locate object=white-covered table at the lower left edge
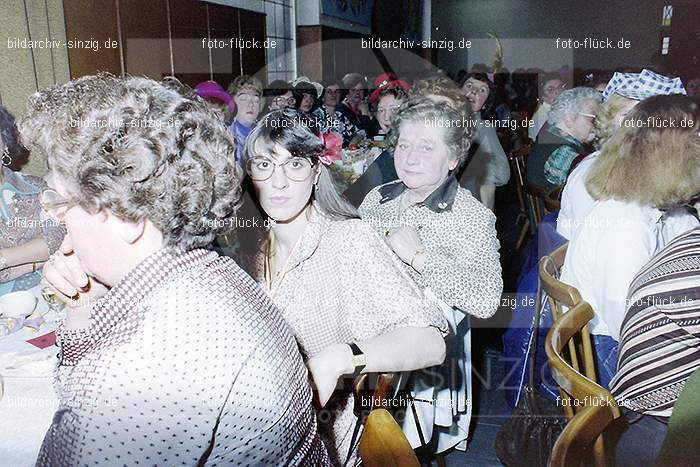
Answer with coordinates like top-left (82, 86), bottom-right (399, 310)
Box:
top-left (0, 287), bottom-right (58, 466)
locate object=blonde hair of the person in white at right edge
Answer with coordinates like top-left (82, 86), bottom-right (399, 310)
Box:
top-left (586, 95), bottom-right (700, 209)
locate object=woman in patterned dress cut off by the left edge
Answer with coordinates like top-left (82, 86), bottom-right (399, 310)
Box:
top-left (0, 106), bottom-right (65, 295)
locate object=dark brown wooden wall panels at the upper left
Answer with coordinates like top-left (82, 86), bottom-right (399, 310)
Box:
top-left (64, 0), bottom-right (265, 87)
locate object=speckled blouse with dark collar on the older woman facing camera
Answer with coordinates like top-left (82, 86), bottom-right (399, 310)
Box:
top-left (360, 176), bottom-right (503, 318)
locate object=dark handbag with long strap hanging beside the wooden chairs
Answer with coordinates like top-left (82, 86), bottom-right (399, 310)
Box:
top-left (496, 286), bottom-right (567, 467)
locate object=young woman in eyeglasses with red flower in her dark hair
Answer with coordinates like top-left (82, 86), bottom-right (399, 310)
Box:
top-left (246, 109), bottom-right (447, 465)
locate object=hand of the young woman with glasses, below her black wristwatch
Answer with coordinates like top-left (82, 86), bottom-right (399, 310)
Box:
top-left (306, 344), bottom-right (354, 407)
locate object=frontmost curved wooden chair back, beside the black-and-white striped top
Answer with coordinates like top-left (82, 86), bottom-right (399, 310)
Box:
top-left (545, 301), bottom-right (620, 467)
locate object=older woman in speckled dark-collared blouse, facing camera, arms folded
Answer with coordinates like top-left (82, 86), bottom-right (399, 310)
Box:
top-left (359, 98), bottom-right (503, 452)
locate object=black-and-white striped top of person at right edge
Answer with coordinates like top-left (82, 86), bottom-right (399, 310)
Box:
top-left (612, 228), bottom-right (700, 418)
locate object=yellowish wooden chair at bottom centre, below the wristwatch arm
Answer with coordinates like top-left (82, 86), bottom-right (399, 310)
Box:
top-left (353, 373), bottom-right (420, 467)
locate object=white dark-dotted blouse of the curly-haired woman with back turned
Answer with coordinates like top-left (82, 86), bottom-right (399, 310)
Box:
top-left (37, 248), bottom-right (330, 466)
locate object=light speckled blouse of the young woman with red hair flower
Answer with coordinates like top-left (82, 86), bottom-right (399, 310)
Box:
top-left (243, 208), bottom-right (447, 465)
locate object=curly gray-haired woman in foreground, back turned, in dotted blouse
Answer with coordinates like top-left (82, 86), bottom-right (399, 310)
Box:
top-left (21, 75), bottom-right (328, 466)
